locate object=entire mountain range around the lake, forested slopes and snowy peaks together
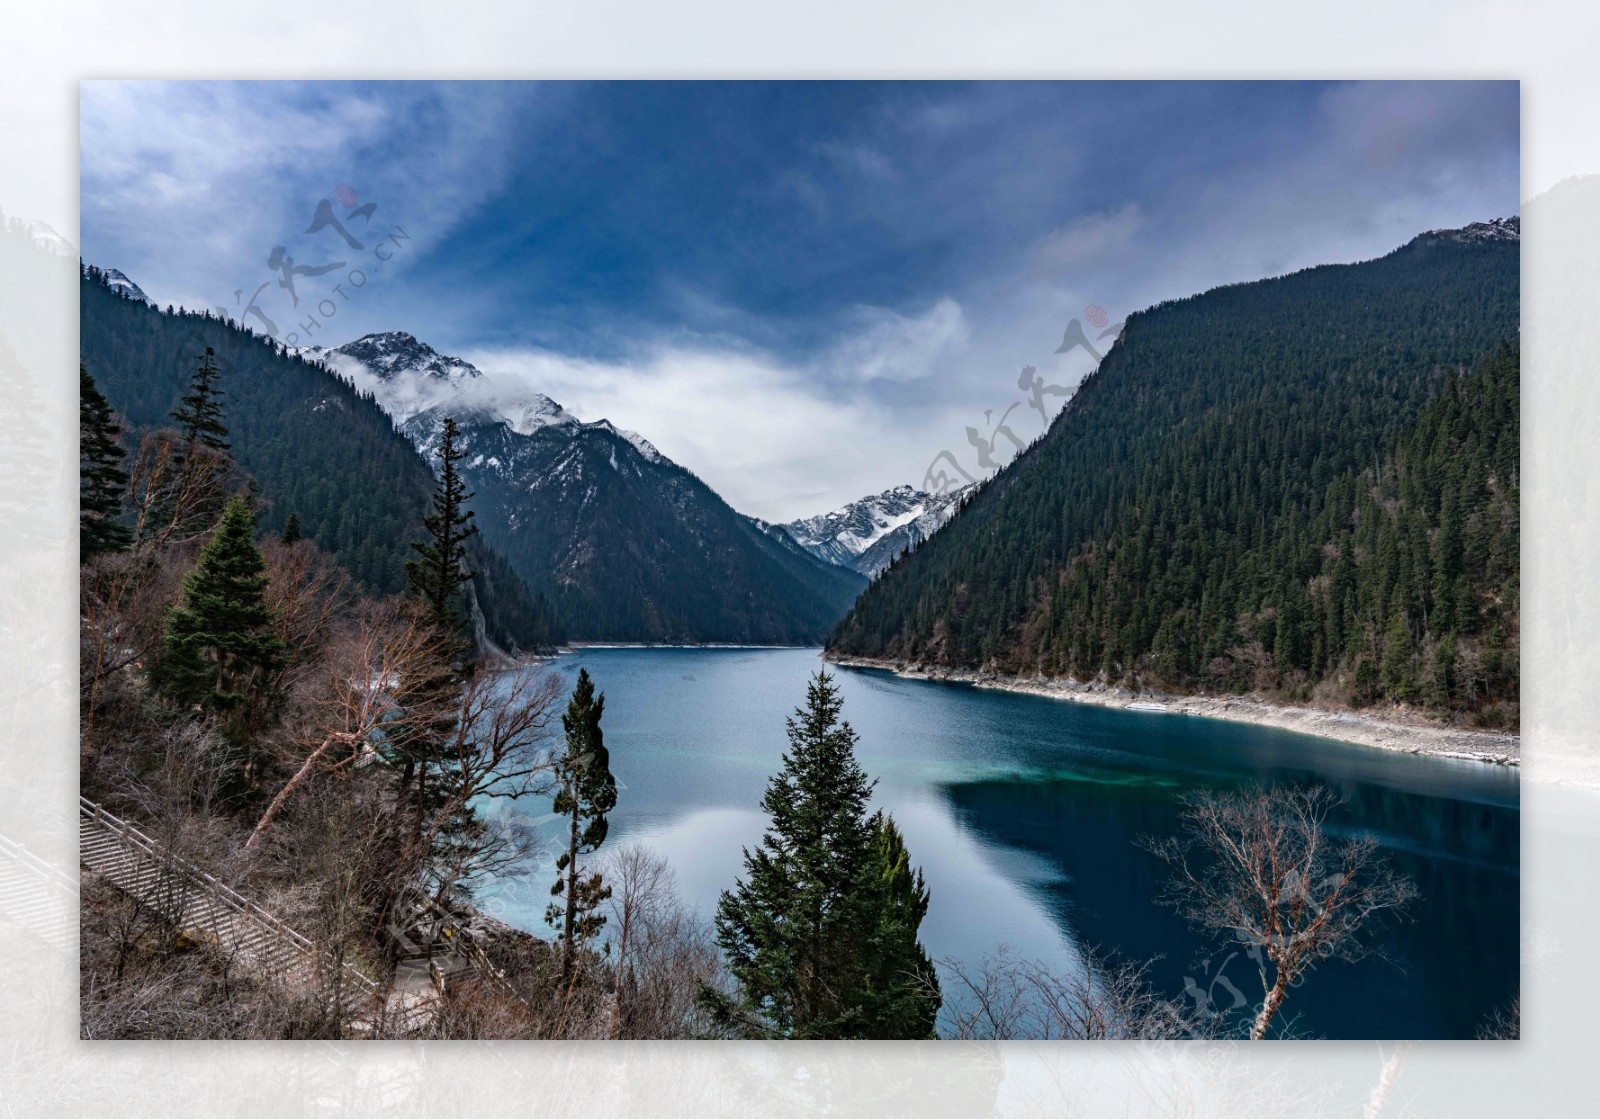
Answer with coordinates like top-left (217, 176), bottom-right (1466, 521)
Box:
top-left (72, 208), bottom-right (1520, 691)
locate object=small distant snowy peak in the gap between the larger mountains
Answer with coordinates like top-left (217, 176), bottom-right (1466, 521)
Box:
top-left (758, 486), bottom-right (965, 576)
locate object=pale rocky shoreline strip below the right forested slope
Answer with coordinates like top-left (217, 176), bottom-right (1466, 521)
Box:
top-left (827, 658), bottom-right (1522, 766)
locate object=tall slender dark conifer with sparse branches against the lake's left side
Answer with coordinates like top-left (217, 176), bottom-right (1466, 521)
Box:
top-left (546, 669), bottom-right (616, 982)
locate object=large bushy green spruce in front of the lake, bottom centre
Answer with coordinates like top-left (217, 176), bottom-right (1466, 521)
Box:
top-left (704, 672), bottom-right (938, 1038)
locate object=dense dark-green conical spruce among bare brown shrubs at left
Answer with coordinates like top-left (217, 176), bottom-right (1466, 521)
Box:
top-left (155, 498), bottom-right (283, 716)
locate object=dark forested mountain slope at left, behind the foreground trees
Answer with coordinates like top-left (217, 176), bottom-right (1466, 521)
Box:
top-left (80, 267), bottom-right (563, 650)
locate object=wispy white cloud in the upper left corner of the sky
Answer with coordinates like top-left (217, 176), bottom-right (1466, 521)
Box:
top-left (80, 82), bottom-right (538, 315)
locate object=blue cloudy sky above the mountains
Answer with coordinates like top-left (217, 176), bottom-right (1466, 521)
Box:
top-left (80, 82), bottom-right (1520, 520)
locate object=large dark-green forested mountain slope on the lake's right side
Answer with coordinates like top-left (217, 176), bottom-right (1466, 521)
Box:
top-left (830, 219), bottom-right (1518, 722)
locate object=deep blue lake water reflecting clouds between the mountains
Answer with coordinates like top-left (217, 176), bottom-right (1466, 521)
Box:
top-left (470, 650), bottom-right (1518, 1038)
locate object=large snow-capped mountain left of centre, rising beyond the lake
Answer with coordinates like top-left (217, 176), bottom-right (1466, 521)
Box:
top-left (302, 331), bottom-right (866, 645)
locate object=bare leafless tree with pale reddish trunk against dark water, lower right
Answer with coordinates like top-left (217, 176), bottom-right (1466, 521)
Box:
top-left (1141, 786), bottom-right (1416, 1038)
